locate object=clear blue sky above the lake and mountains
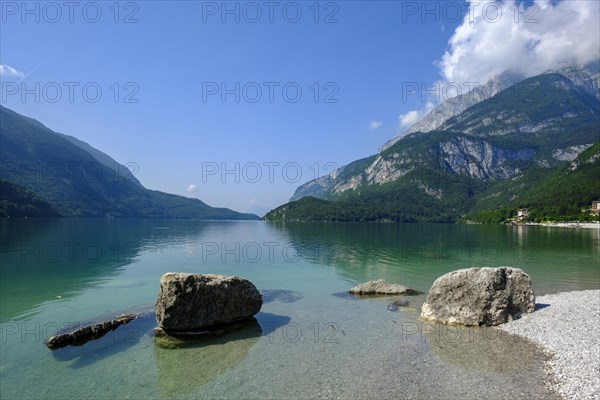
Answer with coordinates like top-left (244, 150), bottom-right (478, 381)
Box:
top-left (0, 1), bottom-right (597, 215)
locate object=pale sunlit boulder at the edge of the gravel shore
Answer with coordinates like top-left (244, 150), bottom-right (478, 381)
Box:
top-left (421, 267), bottom-right (535, 326)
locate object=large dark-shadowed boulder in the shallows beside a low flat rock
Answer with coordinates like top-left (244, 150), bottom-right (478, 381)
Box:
top-left (156, 273), bottom-right (263, 332)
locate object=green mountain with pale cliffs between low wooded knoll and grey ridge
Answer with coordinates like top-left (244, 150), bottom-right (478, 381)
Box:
top-left (276, 73), bottom-right (600, 221)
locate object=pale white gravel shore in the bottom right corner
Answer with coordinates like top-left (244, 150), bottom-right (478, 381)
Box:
top-left (498, 290), bottom-right (600, 399)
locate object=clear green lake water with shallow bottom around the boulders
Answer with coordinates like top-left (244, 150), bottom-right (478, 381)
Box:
top-left (0, 219), bottom-right (600, 399)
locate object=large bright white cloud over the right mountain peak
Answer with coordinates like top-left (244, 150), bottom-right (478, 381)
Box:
top-left (437, 0), bottom-right (600, 84)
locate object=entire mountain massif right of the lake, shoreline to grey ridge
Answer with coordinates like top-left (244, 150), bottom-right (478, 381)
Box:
top-left (264, 62), bottom-right (600, 222)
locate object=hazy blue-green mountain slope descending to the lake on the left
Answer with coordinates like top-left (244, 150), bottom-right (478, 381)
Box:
top-left (0, 107), bottom-right (257, 219)
